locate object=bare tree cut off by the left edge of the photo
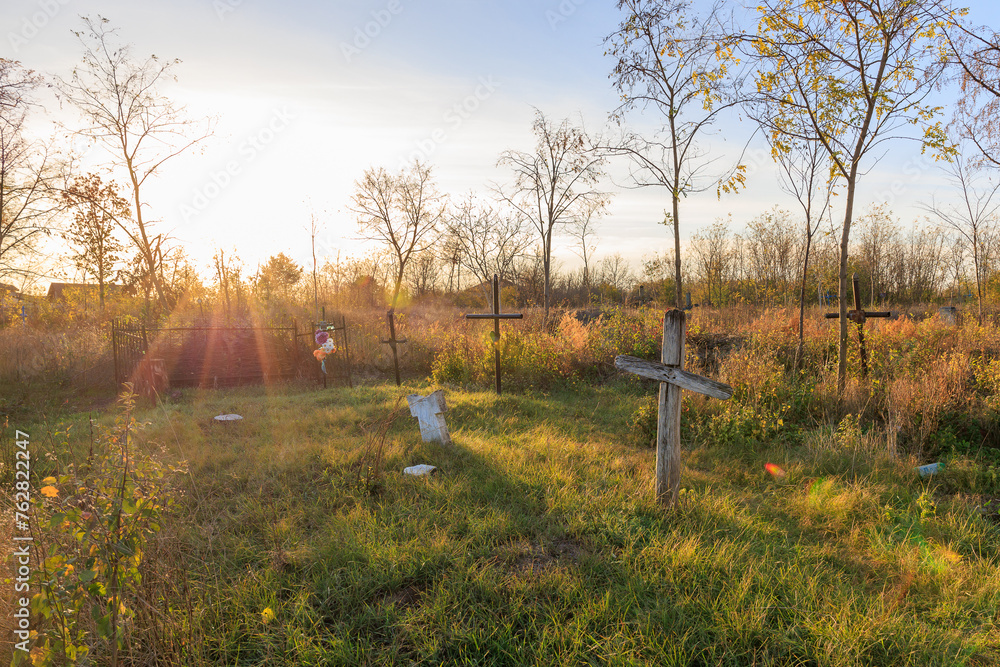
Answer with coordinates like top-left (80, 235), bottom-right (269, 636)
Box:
top-left (0, 58), bottom-right (64, 278)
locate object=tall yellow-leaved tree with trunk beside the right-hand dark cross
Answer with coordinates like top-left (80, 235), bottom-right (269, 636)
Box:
top-left (750, 0), bottom-right (960, 395)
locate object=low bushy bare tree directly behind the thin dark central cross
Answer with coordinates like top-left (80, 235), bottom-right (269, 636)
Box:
top-left (445, 193), bottom-right (531, 298)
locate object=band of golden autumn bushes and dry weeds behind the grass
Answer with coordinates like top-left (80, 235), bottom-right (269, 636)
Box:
top-left (7, 304), bottom-right (1000, 468)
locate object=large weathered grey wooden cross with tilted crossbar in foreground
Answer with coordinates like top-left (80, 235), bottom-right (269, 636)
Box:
top-left (615, 309), bottom-right (733, 507)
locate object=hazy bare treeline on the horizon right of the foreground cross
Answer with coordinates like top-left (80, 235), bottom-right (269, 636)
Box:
top-left (686, 204), bottom-right (984, 306)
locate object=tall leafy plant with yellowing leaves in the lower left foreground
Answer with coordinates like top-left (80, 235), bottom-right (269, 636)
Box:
top-left (15, 388), bottom-right (184, 666)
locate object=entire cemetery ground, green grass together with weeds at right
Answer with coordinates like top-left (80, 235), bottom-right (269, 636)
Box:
top-left (2, 306), bottom-right (1000, 667)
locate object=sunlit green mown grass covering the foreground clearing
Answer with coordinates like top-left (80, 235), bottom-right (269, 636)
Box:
top-left (1, 383), bottom-right (1000, 667)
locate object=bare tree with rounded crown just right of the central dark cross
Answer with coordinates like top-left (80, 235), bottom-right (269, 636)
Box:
top-left (497, 110), bottom-right (605, 321)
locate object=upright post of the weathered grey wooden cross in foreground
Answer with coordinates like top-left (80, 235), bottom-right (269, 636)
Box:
top-left (656, 310), bottom-right (687, 507)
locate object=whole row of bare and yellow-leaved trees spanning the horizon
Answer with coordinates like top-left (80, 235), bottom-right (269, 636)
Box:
top-left (0, 0), bottom-right (1000, 354)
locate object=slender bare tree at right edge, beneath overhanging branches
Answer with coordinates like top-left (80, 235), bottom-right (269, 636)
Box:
top-left (923, 155), bottom-right (1000, 324)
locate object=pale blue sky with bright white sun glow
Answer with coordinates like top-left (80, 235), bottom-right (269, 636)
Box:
top-left (0, 0), bottom-right (1000, 286)
